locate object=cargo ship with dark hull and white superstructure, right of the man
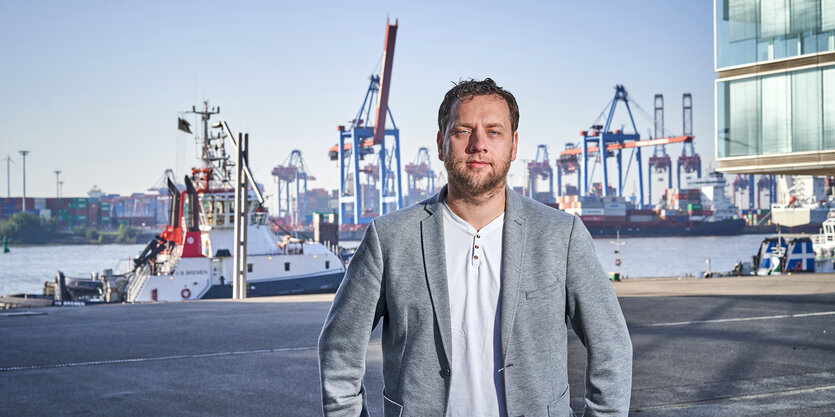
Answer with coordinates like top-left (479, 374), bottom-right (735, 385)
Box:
top-left (551, 172), bottom-right (745, 237)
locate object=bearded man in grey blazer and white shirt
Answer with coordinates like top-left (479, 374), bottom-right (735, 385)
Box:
top-left (319, 78), bottom-right (632, 417)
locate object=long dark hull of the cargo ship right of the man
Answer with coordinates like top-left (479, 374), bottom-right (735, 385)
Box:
top-left (584, 219), bottom-right (745, 237)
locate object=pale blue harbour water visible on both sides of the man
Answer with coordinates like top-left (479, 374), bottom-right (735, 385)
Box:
top-left (0, 235), bottom-right (780, 295)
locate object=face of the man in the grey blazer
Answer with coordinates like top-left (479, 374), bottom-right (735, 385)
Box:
top-left (437, 95), bottom-right (518, 196)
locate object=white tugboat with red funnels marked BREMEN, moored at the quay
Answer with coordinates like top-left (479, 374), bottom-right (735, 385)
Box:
top-left (49, 102), bottom-right (345, 302)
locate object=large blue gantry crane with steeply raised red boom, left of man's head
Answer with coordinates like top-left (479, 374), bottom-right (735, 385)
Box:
top-left (329, 20), bottom-right (402, 225)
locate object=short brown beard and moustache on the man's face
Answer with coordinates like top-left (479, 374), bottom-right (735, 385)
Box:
top-left (444, 153), bottom-right (510, 198)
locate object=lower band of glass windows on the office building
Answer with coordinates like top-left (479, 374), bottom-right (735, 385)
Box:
top-left (716, 66), bottom-right (835, 158)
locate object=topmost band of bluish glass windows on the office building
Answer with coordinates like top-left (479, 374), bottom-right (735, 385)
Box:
top-left (715, 0), bottom-right (835, 68)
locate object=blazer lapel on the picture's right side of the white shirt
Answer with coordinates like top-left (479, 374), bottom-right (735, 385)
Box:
top-left (501, 187), bottom-right (526, 359)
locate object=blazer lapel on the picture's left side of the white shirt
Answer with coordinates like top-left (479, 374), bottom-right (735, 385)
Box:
top-left (420, 186), bottom-right (452, 361)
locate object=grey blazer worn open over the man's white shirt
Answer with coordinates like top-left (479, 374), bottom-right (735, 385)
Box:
top-left (319, 188), bottom-right (632, 417)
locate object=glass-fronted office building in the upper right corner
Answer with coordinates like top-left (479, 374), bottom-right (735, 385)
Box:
top-left (715, 0), bottom-right (835, 175)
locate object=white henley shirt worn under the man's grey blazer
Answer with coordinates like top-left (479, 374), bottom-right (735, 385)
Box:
top-left (444, 202), bottom-right (507, 417)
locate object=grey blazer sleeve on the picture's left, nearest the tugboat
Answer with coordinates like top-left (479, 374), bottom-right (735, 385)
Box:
top-left (319, 221), bottom-right (385, 417)
